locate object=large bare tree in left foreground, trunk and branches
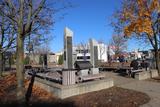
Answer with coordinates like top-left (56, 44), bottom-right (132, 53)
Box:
top-left (0, 0), bottom-right (53, 104)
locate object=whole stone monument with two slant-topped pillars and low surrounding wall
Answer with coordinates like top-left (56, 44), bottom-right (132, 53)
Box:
top-left (26, 27), bottom-right (113, 99)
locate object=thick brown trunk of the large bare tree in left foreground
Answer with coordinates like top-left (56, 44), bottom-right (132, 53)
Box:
top-left (16, 35), bottom-right (25, 104)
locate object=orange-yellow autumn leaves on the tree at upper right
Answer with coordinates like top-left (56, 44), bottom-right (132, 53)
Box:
top-left (124, 0), bottom-right (157, 36)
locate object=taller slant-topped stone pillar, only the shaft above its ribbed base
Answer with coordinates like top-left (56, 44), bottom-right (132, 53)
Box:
top-left (64, 27), bottom-right (73, 69)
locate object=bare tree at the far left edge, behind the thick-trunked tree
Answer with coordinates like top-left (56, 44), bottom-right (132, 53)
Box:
top-left (0, 14), bottom-right (15, 76)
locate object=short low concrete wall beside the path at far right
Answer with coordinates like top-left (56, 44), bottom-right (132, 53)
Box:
top-left (135, 69), bottom-right (158, 80)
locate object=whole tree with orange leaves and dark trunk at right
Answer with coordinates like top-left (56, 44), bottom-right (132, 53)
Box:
top-left (113, 0), bottom-right (160, 74)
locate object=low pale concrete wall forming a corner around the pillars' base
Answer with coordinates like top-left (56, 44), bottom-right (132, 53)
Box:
top-left (35, 78), bottom-right (113, 99)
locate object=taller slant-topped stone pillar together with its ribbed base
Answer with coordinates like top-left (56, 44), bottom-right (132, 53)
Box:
top-left (62, 27), bottom-right (76, 85)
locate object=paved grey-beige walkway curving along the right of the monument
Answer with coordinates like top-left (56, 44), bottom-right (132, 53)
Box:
top-left (105, 72), bottom-right (160, 107)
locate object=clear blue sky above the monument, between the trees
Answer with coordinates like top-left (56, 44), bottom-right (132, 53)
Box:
top-left (50, 0), bottom-right (152, 52)
